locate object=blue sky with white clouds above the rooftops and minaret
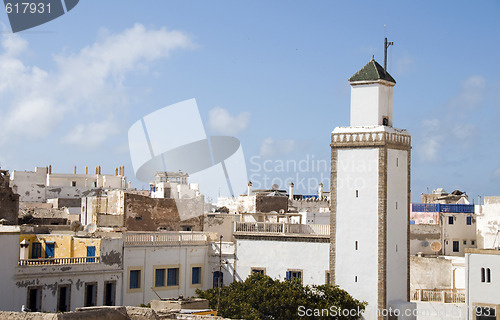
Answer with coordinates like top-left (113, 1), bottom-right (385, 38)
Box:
top-left (0, 0), bottom-right (500, 201)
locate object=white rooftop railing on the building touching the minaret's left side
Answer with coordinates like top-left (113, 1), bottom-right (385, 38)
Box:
top-left (234, 222), bottom-right (330, 236)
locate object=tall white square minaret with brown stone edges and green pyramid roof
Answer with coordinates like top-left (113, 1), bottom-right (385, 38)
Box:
top-left (330, 59), bottom-right (411, 319)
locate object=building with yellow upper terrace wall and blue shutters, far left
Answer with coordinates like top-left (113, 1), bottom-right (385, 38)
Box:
top-left (0, 226), bottom-right (123, 312)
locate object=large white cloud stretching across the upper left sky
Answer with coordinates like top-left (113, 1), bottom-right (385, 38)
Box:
top-left (0, 24), bottom-right (193, 145)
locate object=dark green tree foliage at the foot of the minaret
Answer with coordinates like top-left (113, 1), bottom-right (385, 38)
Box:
top-left (196, 273), bottom-right (366, 320)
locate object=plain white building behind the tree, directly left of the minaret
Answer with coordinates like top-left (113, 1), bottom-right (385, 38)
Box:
top-left (234, 222), bottom-right (330, 285)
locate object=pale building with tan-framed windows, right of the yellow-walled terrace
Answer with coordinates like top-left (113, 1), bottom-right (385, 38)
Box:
top-left (123, 232), bottom-right (234, 306)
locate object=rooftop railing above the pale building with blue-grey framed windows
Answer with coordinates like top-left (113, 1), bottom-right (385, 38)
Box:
top-left (125, 233), bottom-right (208, 246)
